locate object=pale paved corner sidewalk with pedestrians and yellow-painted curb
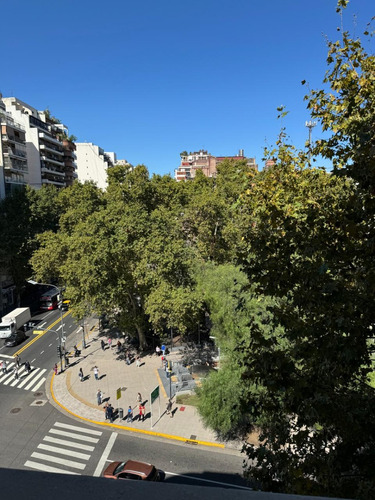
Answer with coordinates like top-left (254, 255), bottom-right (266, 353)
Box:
top-left (50, 320), bottom-right (241, 449)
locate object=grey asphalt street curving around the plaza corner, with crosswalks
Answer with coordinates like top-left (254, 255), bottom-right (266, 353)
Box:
top-left (0, 311), bottom-right (250, 488)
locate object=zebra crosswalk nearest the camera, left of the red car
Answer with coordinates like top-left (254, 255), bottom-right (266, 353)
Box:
top-left (25, 422), bottom-right (103, 475)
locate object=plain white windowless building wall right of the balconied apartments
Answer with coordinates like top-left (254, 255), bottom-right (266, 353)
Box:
top-left (76, 142), bottom-right (116, 189)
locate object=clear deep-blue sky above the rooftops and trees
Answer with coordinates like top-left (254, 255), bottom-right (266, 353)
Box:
top-left (0, 0), bottom-right (375, 174)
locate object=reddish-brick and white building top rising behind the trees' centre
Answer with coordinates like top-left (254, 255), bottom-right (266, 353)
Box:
top-left (175, 149), bottom-right (258, 181)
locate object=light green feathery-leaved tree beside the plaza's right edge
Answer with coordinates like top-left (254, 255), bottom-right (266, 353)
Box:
top-left (197, 263), bottom-right (285, 438)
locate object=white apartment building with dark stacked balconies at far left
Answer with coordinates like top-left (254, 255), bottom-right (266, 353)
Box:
top-left (2, 97), bottom-right (77, 193)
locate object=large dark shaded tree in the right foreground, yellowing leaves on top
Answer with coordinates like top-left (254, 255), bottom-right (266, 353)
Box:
top-left (241, 51), bottom-right (375, 498)
